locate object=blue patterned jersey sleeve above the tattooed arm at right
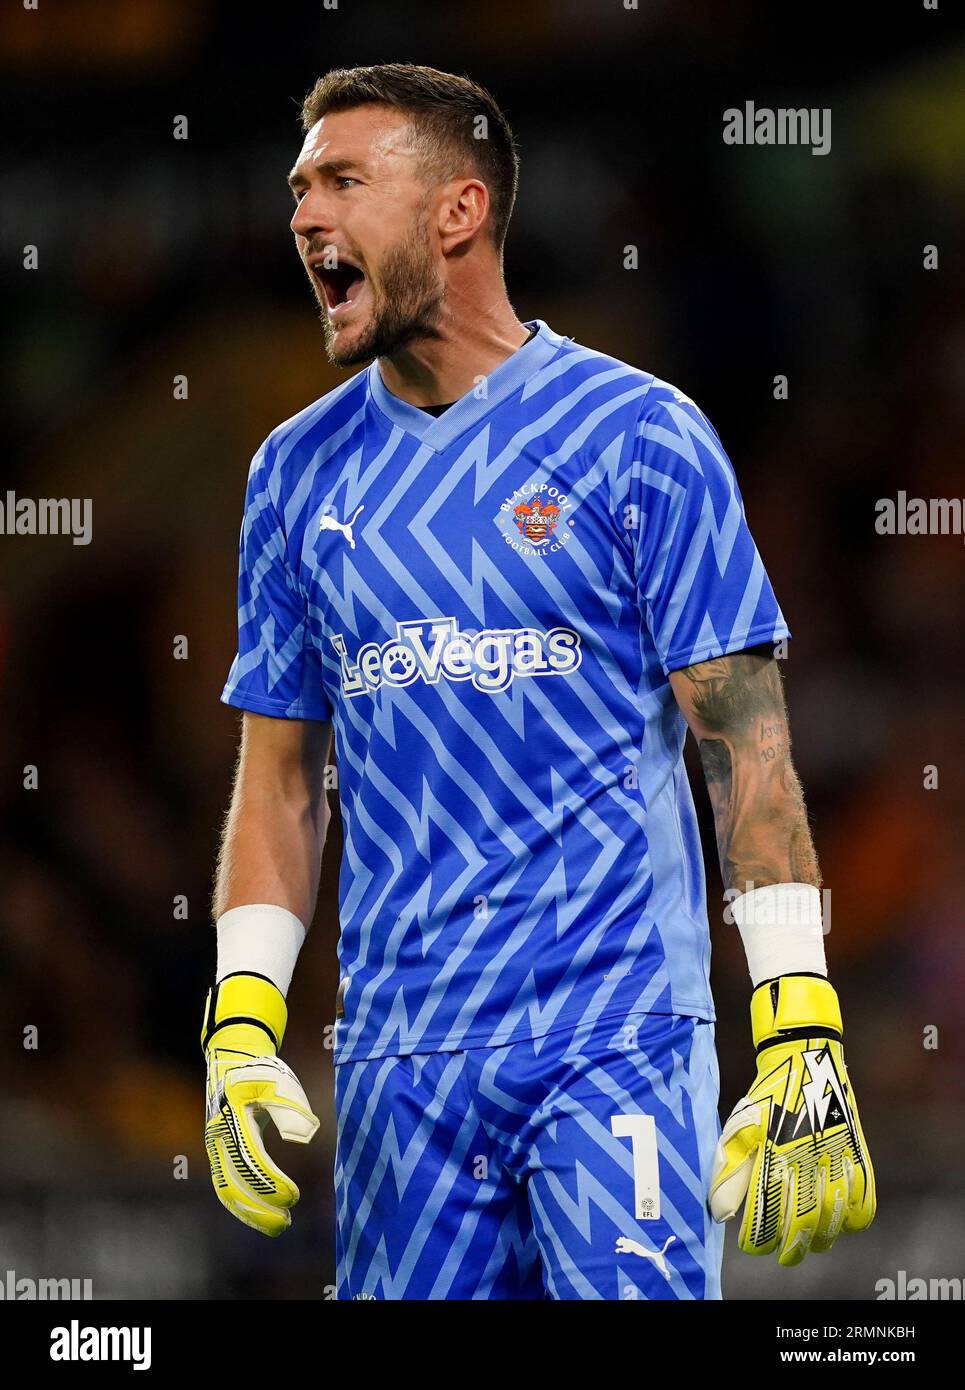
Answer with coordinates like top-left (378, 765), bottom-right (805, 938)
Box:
top-left (622, 381), bottom-right (791, 674)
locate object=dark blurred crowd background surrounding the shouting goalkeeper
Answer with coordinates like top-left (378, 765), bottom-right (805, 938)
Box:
top-left (0, 0), bottom-right (965, 1300)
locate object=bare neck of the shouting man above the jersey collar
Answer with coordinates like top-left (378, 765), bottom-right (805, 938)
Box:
top-left (378, 285), bottom-right (530, 406)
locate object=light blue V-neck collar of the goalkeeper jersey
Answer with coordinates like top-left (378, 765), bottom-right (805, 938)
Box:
top-left (368, 318), bottom-right (569, 449)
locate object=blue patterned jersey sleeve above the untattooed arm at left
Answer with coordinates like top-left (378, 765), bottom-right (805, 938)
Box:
top-left (221, 445), bottom-right (332, 721)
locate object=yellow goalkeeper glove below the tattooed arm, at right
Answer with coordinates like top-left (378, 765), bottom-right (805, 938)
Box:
top-left (711, 974), bottom-right (875, 1265)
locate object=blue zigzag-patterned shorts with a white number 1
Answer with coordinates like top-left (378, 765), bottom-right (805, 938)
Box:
top-left (335, 1015), bottom-right (723, 1300)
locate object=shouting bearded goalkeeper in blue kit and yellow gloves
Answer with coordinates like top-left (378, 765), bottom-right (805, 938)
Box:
top-left (203, 64), bottom-right (875, 1300)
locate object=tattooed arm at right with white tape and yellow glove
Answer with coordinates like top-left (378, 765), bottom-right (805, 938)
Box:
top-left (670, 649), bottom-right (875, 1265)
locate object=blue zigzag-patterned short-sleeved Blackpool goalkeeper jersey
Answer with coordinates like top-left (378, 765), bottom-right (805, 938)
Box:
top-left (222, 321), bottom-right (790, 1062)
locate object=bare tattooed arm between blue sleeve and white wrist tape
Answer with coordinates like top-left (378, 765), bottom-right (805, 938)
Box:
top-left (674, 648), bottom-right (820, 892)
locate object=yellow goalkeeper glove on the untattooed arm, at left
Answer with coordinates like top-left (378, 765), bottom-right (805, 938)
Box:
top-left (202, 974), bottom-right (318, 1236)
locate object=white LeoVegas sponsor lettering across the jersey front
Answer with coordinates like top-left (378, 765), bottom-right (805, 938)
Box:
top-left (332, 617), bottom-right (583, 696)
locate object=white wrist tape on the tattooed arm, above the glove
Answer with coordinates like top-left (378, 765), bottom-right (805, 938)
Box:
top-left (730, 883), bottom-right (827, 988)
